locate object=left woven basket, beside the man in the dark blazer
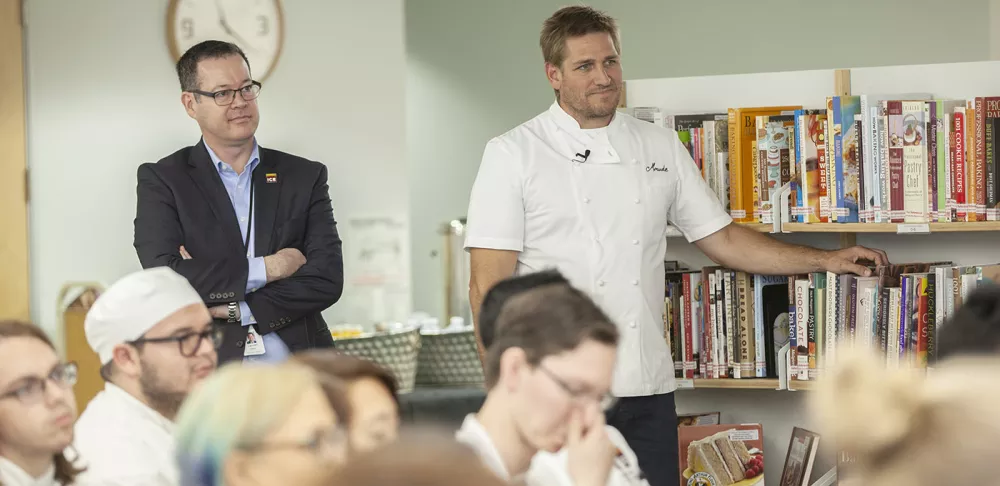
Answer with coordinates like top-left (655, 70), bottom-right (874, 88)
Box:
top-left (333, 328), bottom-right (420, 393)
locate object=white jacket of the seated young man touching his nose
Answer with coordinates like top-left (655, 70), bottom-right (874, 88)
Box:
top-left (455, 414), bottom-right (649, 486)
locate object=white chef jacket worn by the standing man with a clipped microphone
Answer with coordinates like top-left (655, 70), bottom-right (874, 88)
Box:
top-left (465, 103), bottom-right (732, 396)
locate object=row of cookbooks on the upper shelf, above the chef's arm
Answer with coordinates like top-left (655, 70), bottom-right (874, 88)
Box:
top-left (634, 93), bottom-right (1000, 223)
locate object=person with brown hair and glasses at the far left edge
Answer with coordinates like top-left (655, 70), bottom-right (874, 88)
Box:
top-left (0, 321), bottom-right (80, 486)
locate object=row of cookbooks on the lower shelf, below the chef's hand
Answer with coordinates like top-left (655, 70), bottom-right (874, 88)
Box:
top-left (663, 261), bottom-right (1000, 380)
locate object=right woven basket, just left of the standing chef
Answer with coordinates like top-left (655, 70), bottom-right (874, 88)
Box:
top-left (417, 329), bottom-right (484, 386)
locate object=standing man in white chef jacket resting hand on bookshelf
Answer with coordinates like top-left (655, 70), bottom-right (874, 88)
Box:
top-left (465, 6), bottom-right (888, 486)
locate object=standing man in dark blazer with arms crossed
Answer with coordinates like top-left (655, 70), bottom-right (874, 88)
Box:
top-left (134, 41), bottom-right (344, 363)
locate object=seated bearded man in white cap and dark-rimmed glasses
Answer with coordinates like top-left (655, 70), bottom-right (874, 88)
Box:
top-left (75, 267), bottom-right (221, 486)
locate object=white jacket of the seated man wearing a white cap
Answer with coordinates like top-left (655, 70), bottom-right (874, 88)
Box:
top-left (74, 383), bottom-right (179, 486)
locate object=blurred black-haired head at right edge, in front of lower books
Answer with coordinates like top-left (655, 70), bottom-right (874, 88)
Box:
top-left (931, 284), bottom-right (1000, 362)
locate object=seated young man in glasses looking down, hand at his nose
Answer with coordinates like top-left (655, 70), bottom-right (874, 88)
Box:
top-left (456, 271), bottom-right (648, 486)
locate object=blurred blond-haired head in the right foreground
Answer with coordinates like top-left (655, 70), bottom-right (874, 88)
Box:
top-left (810, 349), bottom-right (1000, 486)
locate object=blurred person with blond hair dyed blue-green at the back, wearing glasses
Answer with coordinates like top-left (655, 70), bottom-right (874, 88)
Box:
top-left (177, 362), bottom-right (347, 486)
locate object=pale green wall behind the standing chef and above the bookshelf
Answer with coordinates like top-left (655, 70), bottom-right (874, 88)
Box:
top-left (406, 0), bottom-right (990, 320)
